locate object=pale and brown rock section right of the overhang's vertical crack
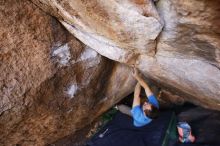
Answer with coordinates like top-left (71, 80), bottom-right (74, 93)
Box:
top-left (142, 0), bottom-right (220, 110)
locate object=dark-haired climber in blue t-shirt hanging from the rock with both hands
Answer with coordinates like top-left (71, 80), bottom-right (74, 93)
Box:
top-left (117, 68), bottom-right (159, 127)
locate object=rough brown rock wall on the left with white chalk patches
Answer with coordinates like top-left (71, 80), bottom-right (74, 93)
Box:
top-left (0, 0), bottom-right (135, 146)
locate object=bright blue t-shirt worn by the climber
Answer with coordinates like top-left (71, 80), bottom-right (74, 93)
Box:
top-left (131, 94), bottom-right (159, 127)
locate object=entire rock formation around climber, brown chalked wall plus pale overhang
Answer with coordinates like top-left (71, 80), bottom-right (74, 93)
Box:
top-left (0, 0), bottom-right (220, 145)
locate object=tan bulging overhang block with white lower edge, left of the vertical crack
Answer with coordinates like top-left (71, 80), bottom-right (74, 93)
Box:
top-left (33, 0), bottom-right (163, 63)
